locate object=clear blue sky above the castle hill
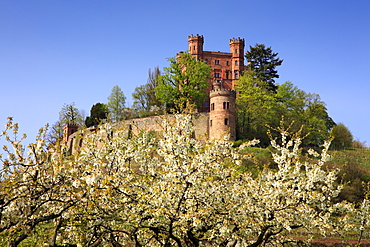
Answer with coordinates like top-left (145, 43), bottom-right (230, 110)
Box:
top-left (0, 0), bottom-right (370, 145)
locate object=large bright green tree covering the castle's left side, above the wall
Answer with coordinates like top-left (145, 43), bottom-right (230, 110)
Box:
top-left (155, 53), bottom-right (211, 112)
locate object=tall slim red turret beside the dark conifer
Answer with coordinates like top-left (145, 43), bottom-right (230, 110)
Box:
top-left (230, 38), bottom-right (245, 86)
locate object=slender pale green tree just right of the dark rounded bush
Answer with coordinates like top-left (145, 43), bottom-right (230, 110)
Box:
top-left (107, 85), bottom-right (126, 122)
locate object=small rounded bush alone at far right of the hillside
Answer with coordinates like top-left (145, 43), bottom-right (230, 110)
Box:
top-left (330, 123), bottom-right (353, 149)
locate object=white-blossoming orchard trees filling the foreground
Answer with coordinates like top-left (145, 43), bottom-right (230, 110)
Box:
top-left (0, 115), bottom-right (369, 247)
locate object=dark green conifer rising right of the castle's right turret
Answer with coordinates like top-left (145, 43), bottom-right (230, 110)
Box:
top-left (245, 44), bottom-right (283, 92)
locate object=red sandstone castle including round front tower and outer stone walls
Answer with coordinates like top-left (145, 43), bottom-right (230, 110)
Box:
top-left (63, 35), bottom-right (246, 152)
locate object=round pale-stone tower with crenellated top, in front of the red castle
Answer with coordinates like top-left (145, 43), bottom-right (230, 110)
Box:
top-left (209, 80), bottom-right (236, 141)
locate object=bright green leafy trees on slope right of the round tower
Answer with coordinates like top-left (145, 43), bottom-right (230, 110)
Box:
top-left (235, 77), bottom-right (335, 147)
